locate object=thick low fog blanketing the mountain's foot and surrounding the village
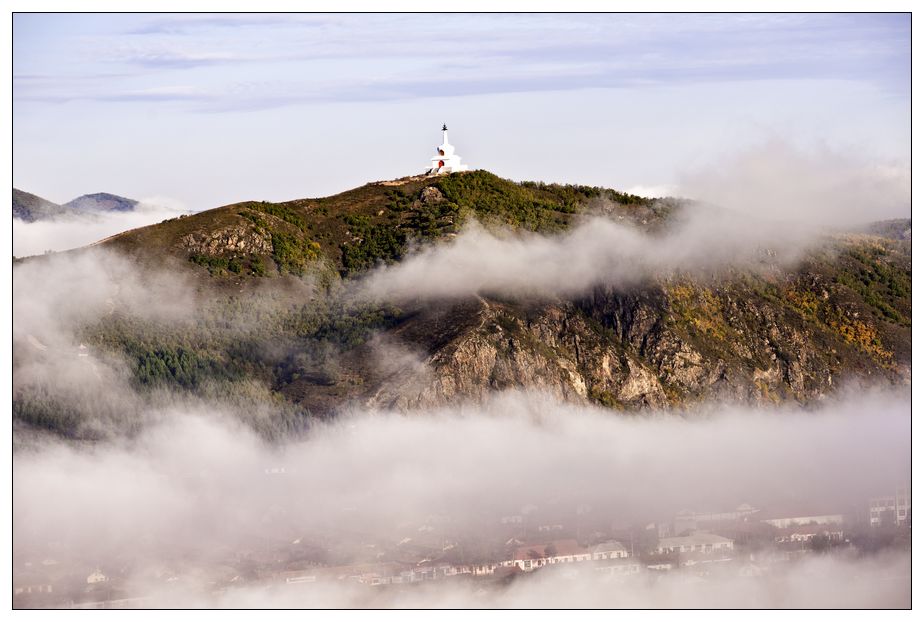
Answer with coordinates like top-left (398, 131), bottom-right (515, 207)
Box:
top-left (13, 393), bottom-right (910, 607)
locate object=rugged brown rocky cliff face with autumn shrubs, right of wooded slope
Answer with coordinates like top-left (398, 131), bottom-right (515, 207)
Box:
top-left (338, 236), bottom-right (910, 410)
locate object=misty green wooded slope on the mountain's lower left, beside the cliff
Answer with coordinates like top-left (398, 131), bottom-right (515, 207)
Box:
top-left (13, 292), bottom-right (403, 439)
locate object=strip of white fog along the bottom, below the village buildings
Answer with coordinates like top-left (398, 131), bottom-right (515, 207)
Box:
top-left (159, 553), bottom-right (911, 609)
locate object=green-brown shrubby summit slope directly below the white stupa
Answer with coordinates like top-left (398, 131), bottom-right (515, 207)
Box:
top-left (97, 171), bottom-right (652, 276)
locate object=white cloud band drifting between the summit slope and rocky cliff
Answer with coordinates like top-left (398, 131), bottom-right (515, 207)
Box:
top-left (359, 211), bottom-right (814, 300)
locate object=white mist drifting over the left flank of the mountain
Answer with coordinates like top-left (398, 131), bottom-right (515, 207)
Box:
top-left (13, 248), bottom-right (322, 443)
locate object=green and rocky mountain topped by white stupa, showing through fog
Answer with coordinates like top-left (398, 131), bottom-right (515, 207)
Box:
top-left (14, 171), bottom-right (911, 436)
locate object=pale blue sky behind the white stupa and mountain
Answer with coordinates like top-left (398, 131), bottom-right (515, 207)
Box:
top-left (13, 14), bottom-right (911, 210)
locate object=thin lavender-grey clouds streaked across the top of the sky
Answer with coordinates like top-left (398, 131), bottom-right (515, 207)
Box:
top-left (15, 14), bottom-right (909, 110)
